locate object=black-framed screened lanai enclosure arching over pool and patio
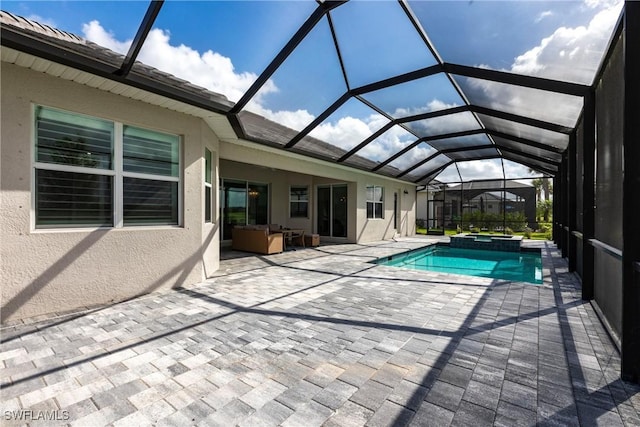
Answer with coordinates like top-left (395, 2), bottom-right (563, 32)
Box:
top-left (2, 0), bottom-right (640, 381)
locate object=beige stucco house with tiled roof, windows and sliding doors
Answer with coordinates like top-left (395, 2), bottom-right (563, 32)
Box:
top-left (0, 12), bottom-right (415, 322)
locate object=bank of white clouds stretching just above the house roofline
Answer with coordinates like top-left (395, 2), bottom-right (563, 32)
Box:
top-left (82, 20), bottom-right (468, 171)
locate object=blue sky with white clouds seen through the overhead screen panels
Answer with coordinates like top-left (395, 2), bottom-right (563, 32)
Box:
top-left (2, 0), bottom-right (622, 181)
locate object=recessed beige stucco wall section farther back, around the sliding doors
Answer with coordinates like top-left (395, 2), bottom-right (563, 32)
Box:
top-left (220, 141), bottom-right (416, 242)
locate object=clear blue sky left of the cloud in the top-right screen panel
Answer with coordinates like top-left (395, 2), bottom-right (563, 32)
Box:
top-left (410, 1), bottom-right (596, 69)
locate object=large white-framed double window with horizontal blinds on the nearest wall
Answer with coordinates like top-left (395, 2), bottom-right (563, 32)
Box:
top-left (35, 107), bottom-right (180, 228)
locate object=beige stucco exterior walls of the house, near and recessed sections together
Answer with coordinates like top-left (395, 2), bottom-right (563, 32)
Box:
top-left (0, 58), bottom-right (416, 323)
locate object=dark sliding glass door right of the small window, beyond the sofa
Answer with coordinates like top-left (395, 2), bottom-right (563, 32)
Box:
top-left (317, 184), bottom-right (347, 237)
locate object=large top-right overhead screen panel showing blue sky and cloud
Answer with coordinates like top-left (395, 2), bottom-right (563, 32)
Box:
top-left (408, 0), bottom-right (623, 84)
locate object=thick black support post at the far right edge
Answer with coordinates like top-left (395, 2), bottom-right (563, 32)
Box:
top-left (621, 0), bottom-right (640, 382)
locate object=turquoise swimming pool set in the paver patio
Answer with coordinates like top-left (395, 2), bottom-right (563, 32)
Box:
top-left (376, 245), bottom-right (542, 284)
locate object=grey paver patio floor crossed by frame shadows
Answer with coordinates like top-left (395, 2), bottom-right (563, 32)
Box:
top-left (0, 237), bottom-right (640, 427)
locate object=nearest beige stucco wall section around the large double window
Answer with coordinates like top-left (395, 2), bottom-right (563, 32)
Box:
top-left (0, 63), bottom-right (219, 322)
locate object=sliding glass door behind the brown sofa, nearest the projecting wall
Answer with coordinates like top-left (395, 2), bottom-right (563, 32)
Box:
top-left (220, 179), bottom-right (269, 240)
